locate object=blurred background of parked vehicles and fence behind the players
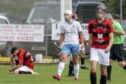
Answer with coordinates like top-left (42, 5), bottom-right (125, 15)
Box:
top-left (0, 0), bottom-right (126, 61)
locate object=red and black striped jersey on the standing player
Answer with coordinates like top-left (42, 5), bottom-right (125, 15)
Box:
top-left (88, 19), bottom-right (114, 49)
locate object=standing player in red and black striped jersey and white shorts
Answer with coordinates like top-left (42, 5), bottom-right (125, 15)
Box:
top-left (88, 9), bottom-right (114, 84)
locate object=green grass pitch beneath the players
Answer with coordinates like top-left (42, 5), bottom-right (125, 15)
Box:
top-left (0, 62), bottom-right (126, 84)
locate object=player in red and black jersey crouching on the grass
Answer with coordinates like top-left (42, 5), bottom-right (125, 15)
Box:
top-left (9, 47), bottom-right (38, 75)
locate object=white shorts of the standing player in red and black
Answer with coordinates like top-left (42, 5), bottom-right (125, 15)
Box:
top-left (90, 48), bottom-right (110, 66)
